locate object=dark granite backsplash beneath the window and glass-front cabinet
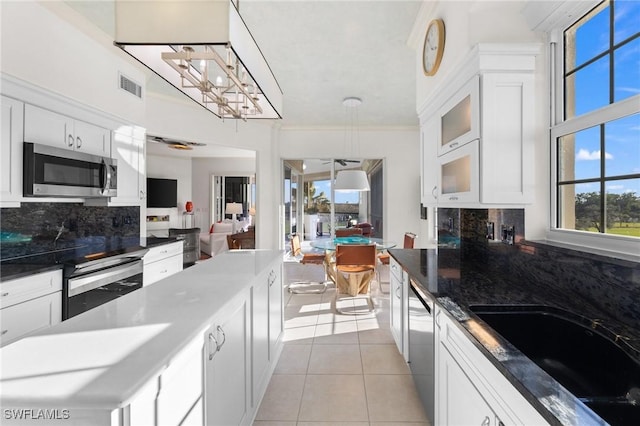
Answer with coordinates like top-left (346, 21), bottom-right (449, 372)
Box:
top-left (437, 209), bottom-right (640, 327)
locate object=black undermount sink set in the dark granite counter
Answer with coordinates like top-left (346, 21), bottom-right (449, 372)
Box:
top-left (470, 305), bottom-right (640, 425)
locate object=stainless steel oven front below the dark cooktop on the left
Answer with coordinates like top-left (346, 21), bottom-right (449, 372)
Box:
top-left (62, 251), bottom-right (146, 320)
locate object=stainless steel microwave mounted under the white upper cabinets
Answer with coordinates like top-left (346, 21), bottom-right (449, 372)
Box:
top-left (23, 142), bottom-right (118, 198)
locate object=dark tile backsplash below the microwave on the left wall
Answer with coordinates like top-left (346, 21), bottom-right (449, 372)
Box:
top-left (0, 202), bottom-right (140, 259)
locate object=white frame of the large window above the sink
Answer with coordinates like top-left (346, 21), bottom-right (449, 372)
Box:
top-left (546, 1), bottom-right (640, 261)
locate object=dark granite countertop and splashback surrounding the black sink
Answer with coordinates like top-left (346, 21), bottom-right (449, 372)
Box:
top-left (389, 245), bottom-right (640, 425)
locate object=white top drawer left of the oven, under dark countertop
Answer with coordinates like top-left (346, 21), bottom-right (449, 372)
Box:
top-left (0, 269), bottom-right (62, 309)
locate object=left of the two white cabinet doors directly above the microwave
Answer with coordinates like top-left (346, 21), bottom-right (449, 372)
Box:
top-left (24, 104), bottom-right (76, 150)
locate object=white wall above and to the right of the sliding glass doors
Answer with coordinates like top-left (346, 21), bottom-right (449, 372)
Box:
top-left (278, 128), bottom-right (420, 242)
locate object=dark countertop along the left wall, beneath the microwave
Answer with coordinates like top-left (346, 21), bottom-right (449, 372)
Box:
top-left (0, 237), bottom-right (182, 282)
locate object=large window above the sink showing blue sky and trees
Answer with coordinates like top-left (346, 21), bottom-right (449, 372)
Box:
top-left (551, 0), bottom-right (640, 250)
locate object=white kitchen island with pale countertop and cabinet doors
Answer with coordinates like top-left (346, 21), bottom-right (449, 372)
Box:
top-left (0, 250), bottom-right (283, 425)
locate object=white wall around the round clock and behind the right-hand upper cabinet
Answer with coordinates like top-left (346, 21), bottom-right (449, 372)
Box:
top-left (414, 0), bottom-right (550, 239)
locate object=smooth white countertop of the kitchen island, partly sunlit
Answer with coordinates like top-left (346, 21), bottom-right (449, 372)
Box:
top-left (0, 250), bottom-right (282, 409)
